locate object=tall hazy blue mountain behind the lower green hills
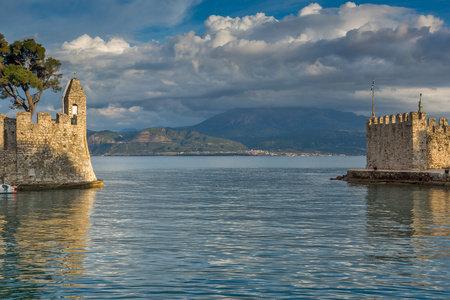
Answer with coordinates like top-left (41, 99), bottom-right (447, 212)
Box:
top-left (188, 108), bottom-right (366, 155)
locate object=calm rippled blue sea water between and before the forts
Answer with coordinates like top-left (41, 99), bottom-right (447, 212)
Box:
top-left (0, 157), bottom-right (450, 299)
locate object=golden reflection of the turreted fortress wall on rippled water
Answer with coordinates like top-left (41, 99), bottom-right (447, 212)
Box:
top-left (0, 189), bottom-right (96, 298)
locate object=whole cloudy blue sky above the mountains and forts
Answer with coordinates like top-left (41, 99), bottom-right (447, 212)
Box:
top-left (0, 0), bottom-right (450, 130)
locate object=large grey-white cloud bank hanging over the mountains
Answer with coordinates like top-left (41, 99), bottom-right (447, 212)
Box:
top-left (52, 2), bottom-right (450, 131)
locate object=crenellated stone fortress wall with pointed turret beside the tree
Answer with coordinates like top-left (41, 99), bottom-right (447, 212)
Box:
top-left (0, 77), bottom-right (102, 189)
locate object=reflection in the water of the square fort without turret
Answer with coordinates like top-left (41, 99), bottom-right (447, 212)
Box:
top-left (367, 184), bottom-right (450, 259)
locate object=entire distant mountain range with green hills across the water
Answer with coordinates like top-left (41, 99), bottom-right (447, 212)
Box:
top-left (88, 108), bottom-right (366, 155)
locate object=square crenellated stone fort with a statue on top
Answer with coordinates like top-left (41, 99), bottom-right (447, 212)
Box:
top-left (366, 112), bottom-right (450, 170)
